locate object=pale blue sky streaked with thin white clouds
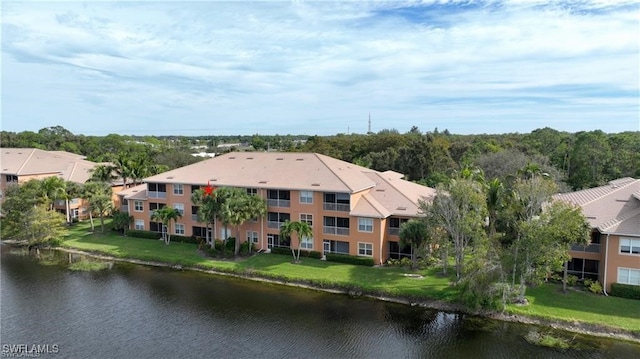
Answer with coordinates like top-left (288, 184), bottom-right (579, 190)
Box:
top-left (1, 0), bottom-right (640, 135)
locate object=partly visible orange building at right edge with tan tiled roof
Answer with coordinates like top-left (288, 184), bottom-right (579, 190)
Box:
top-left (554, 178), bottom-right (640, 290)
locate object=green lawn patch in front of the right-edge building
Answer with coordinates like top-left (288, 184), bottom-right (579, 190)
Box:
top-left (507, 284), bottom-right (640, 333)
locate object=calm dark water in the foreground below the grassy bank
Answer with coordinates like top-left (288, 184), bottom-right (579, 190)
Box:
top-left (0, 246), bottom-right (640, 358)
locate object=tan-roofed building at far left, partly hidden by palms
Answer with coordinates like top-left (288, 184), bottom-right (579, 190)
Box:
top-left (0, 148), bottom-right (122, 219)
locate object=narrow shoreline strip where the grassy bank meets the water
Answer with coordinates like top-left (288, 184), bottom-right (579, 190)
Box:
top-left (53, 247), bottom-right (640, 344)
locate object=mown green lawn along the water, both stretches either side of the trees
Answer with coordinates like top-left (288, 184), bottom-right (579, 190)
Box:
top-left (57, 223), bottom-right (640, 340)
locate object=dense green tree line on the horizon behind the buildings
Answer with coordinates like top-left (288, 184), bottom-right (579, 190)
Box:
top-left (0, 126), bottom-right (640, 191)
